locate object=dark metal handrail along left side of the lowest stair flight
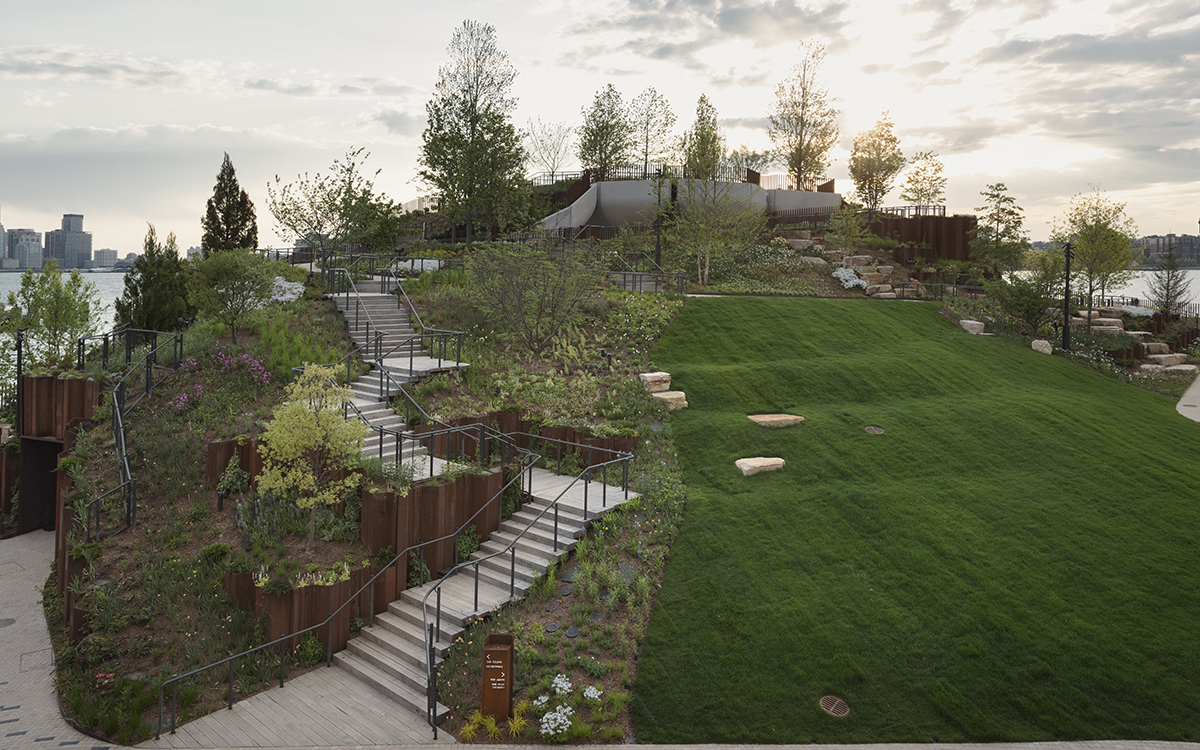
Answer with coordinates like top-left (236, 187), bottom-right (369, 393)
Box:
top-left (155, 417), bottom-right (540, 739)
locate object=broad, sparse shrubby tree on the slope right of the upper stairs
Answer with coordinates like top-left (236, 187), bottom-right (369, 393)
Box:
top-left (467, 246), bottom-right (600, 360)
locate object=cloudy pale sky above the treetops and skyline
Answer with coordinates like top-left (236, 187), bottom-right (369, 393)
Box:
top-left (0, 0), bottom-right (1200, 256)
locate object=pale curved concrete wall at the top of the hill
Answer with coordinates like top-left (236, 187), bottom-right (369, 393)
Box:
top-left (541, 180), bottom-right (841, 229)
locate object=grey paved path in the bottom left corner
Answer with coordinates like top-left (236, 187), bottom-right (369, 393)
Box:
top-left (0, 532), bottom-right (99, 750)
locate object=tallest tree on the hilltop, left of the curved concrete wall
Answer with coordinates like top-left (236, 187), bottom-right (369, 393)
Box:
top-left (418, 20), bottom-right (527, 242)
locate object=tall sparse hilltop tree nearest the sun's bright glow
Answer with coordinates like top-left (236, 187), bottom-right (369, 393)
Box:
top-left (768, 40), bottom-right (838, 190)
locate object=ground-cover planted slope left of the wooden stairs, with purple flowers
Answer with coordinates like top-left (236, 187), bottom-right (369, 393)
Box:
top-left (46, 283), bottom-right (368, 744)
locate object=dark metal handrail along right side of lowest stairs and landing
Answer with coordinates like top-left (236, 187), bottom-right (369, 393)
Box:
top-left (421, 432), bottom-right (634, 739)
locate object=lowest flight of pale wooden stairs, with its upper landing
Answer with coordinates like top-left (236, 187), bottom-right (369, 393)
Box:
top-left (334, 468), bottom-right (637, 721)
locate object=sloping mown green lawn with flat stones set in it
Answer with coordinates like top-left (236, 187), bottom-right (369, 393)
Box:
top-left (634, 298), bottom-right (1200, 743)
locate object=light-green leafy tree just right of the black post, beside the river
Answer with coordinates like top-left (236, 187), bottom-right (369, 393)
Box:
top-left (1050, 188), bottom-right (1140, 331)
